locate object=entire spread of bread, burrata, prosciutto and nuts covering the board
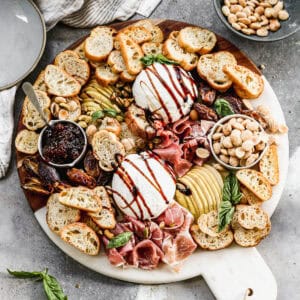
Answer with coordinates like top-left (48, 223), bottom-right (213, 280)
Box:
top-left (15, 20), bottom-right (288, 272)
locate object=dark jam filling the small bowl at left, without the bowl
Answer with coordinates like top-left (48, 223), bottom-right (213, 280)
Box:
top-left (42, 122), bottom-right (84, 164)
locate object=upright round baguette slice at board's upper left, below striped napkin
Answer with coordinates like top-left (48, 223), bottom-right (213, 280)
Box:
top-left (84, 26), bottom-right (116, 61)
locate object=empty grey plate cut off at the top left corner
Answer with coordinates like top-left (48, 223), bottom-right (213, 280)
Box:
top-left (0, 0), bottom-right (46, 90)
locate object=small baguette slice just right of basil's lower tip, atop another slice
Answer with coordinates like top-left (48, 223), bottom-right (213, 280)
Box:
top-left (237, 205), bottom-right (269, 229)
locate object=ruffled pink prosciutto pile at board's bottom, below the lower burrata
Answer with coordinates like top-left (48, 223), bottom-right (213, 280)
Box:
top-left (102, 202), bottom-right (196, 271)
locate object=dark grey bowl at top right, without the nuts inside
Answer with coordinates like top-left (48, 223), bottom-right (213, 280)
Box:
top-left (214, 0), bottom-right (300, 42)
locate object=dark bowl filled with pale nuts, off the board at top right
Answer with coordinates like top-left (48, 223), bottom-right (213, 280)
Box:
top-left (214, 0), bottom-right (300, 41)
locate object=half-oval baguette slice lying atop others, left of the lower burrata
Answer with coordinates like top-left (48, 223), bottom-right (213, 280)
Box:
top-left (58, 186), bottom-right (102, 212)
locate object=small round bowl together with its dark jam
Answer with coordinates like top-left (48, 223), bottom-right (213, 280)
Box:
top-left (39, 120), bottom-right (87, 167)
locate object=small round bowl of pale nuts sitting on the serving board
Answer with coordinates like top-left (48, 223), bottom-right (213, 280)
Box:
top-left (208, 114), bottom-right (268, 170)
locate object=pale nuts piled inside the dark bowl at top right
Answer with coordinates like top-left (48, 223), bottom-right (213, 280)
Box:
top-left (222, 0), bottom-right (289, 36)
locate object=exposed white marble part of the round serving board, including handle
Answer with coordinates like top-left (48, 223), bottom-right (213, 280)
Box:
top-left (35, 78), bottom-right (289, 300)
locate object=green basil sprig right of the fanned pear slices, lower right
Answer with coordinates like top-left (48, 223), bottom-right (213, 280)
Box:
top-left (218, 173), bottom-right (242, 232)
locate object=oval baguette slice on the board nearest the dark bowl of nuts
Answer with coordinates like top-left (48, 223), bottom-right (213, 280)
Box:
top-left (178, 26), bottom-right (217, 55)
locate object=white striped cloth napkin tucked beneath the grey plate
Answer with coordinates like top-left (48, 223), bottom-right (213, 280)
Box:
top-left (0, 0), bottom-right (161, 178)
